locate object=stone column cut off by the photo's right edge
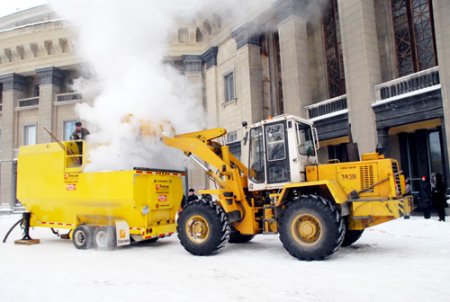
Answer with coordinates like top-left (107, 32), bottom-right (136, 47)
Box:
top-left (433, 0), bottom-right (450, 185)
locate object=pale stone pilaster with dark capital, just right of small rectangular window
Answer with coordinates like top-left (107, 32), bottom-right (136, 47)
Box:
top-left (232, 24), bottom-right (264, 123)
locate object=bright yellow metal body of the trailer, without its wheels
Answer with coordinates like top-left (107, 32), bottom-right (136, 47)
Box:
top-left (17, 143), bottom-right (183, 241)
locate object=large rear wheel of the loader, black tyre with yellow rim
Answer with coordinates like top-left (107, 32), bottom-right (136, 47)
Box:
top-left (279, 195), bottom-right (345, 261)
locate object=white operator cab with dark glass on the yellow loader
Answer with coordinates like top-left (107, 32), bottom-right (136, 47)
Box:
top-left (244, 115), bottom-right (319, 191)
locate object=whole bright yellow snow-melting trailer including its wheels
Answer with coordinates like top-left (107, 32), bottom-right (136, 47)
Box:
top-left (17, 142), bottom-right (184, 249)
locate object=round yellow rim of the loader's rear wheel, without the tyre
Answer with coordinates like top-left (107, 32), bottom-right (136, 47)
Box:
top-left (291, 214), bottom-right (322, 245)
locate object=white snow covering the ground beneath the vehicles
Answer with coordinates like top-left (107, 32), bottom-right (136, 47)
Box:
top-left (0, 215), bottom-right (450, 302)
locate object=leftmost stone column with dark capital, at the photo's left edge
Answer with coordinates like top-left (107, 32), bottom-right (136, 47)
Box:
top-left (0, 73), bottom-right (26, 207)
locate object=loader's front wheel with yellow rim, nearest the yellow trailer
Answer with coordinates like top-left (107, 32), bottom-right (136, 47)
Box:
top-left (177, 199), bottom-right (230, 256)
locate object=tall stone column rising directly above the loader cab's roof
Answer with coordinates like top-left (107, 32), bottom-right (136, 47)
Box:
top-left (278, 1), bottom-right (312, 118)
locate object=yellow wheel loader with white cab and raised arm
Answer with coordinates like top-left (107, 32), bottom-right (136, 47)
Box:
top-left (163, 115), bottom-right (412, 260)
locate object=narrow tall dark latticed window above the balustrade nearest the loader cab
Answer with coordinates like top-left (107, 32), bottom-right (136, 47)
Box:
top-left (322, 0), bottom-right (345, 98)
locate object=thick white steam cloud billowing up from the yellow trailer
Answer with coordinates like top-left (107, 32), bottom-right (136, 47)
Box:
top-left (51, 0), bottom-right (273, 171)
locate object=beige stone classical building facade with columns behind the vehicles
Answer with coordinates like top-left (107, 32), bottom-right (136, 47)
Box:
top-left (0, 0), bottom-right (450, 210)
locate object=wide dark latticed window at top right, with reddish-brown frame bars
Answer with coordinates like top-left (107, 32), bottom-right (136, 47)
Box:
top-left (391, 0), bottom-right (437, 76)
